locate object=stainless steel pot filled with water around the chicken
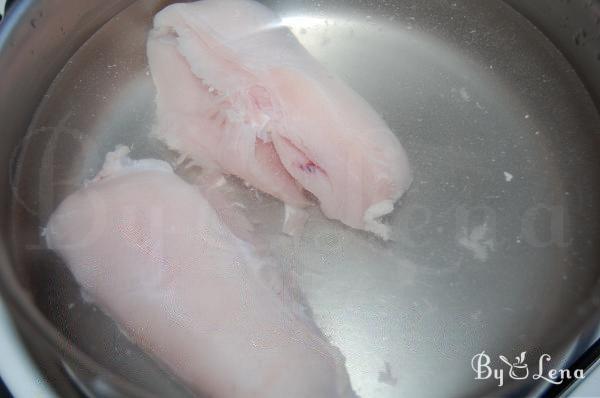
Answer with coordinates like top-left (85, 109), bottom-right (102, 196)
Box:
top-left (0, 0), bottom-right (600, 397)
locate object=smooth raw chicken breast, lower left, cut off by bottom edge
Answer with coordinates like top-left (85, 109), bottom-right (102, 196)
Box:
top-left (46, 148), bottom-right (355, 398)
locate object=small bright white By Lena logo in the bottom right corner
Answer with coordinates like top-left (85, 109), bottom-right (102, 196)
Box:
top-left (471, 351), bottom-right (585, 387)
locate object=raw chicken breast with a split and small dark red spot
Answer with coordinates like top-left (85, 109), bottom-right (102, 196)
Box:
top-left (148, 0), bottom-right (411, 238)
